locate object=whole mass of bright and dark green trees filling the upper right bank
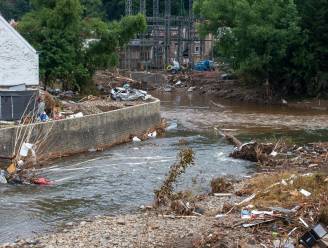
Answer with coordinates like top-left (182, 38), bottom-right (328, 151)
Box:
top-left (194, 0), bottom-right (328, 96)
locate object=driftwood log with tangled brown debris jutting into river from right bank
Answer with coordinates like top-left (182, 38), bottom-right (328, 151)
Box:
top-left (221, 132), bottom-right (274, 163)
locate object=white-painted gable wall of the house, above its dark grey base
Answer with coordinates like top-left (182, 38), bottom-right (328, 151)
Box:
top-left (0, 15), bottom-right (39, 87)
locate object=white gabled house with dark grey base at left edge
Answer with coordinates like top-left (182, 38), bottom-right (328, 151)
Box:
top-left (0, 14), bottom-right (39, 120)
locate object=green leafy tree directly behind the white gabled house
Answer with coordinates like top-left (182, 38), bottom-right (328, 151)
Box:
top-left (18, 0), bottom-right (146, 89)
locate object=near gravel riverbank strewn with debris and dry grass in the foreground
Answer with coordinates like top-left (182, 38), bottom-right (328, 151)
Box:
top-left (2, 143), bottom-right (328, 248)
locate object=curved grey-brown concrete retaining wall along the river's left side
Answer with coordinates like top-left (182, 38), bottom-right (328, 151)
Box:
top-left (0, 100), bottom-right (160, 165)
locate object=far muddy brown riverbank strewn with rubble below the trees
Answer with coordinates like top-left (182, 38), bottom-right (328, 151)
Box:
top-left (120, 71), bottom-right (328, 108)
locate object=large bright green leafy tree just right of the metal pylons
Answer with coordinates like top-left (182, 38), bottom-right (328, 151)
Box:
top-left (194, 0), bottom-right (301, 95)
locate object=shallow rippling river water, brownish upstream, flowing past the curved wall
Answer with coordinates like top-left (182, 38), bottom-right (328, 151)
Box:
top-left (0, 93), bottom-right (328, 243)
